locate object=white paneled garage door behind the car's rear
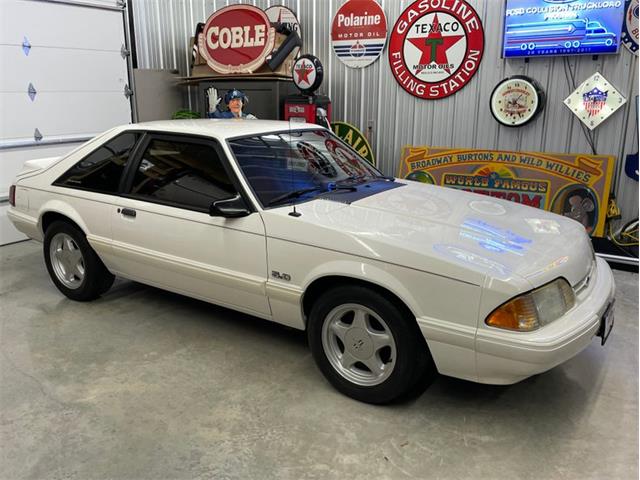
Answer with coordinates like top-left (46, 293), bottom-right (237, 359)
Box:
top-left (0, 0), bottom-right (131, 245)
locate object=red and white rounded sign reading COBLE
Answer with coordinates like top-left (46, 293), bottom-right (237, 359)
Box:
top-left (198, 5), bottom-right (275, 73)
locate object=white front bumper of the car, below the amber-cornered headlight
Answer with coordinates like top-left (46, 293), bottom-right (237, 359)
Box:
top-left (475, 258), bottom-right (615, 385)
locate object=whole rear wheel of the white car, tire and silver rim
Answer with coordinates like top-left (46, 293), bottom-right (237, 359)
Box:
top-left (43, 221), bottom-right (115, 302)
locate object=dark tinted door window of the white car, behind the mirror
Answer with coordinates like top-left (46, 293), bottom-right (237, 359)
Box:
top-left (130, 139), bottom-right (236, 211)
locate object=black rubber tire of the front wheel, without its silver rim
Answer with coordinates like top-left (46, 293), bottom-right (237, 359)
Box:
top-left (307, 286), bottom-right (430, 404)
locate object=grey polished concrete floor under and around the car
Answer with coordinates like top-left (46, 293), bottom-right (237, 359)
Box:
top-left (0, 242), bottom-right (638, 480)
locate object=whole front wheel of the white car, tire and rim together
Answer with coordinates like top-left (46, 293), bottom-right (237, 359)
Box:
top-left (307, 286), bottom-right (436, 404)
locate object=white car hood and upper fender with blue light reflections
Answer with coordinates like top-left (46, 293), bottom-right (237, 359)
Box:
top-left (264, 180), bottom-right (593, 287)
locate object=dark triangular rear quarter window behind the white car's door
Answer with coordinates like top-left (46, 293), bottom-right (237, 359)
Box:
top-left (54, 132), bottom-right (141, 193)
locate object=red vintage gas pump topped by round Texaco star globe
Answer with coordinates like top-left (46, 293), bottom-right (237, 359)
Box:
top-left (284, 55), bottom-right (331, 129)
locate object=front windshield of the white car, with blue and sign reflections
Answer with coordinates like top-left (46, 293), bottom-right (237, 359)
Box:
top-left (229, 130), bottom-right (386, 207)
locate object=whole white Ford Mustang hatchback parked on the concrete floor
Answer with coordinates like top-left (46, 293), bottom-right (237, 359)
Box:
top-left (9, 120), bottom-right (615, 403)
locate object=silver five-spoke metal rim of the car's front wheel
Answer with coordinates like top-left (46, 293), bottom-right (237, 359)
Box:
top-left (322, 303), bottom-right (397, 387)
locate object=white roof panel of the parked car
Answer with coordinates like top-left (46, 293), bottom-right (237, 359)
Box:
top-left (118, 118), bottom-right (323, 140)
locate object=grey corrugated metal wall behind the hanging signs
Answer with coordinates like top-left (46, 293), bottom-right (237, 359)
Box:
top-left (132, 0), bottom-right (638, 224)
